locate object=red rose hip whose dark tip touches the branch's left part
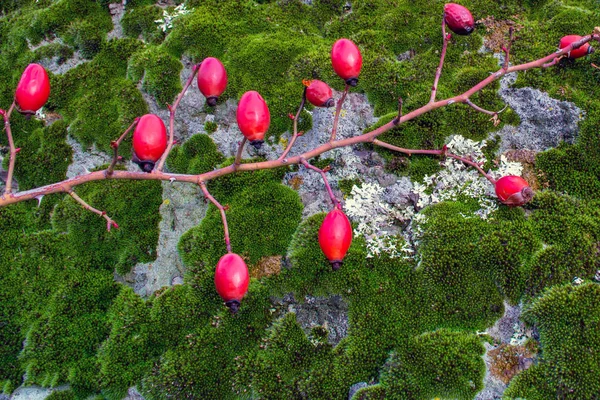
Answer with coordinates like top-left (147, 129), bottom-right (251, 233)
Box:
top-left (133, 114), bottom-right (167, 172)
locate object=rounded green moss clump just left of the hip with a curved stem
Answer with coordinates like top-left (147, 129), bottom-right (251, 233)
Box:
top-left (127, 46), bottom-right (183, 106)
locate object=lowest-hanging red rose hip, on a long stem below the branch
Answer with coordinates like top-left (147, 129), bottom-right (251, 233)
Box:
top-left (215, 253), bottom-right (250, 313)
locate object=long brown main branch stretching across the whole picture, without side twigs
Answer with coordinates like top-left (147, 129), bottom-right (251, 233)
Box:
top-left (0, 34), bottom-right (600, 207)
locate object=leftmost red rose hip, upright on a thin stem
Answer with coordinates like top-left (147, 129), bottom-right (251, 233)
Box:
top-left (15, 64), bottom-right (50, 114)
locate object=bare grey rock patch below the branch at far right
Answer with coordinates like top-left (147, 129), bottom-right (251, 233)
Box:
top-left (490, 54), bottom-right (584, 153)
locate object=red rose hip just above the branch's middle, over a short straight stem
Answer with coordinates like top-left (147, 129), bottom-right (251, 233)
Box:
top-left (237, 90), bottom-right (271, 149)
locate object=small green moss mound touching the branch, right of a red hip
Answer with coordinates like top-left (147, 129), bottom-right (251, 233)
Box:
top-left (167, 134), bottom-right (223, 174)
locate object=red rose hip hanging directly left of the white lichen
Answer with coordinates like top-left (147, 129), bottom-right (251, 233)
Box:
top-left (319, 208), bottom-right (352, 270)
